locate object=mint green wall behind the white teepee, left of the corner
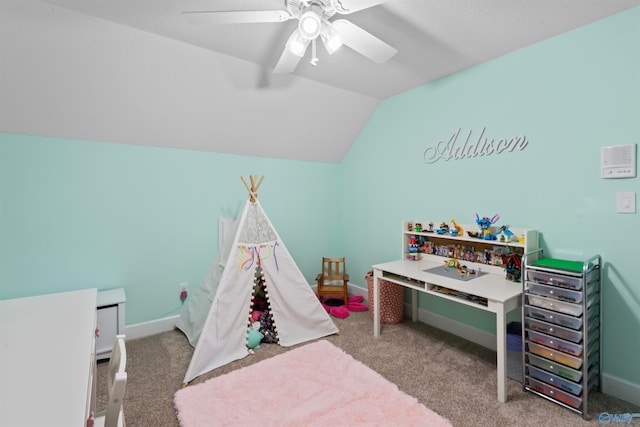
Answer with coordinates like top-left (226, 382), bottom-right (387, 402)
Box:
top-left (0, 134), bottom-right (337, 324)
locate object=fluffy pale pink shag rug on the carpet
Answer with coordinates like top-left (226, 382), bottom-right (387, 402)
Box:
top-left (174, 340), bottom-right (451, 427)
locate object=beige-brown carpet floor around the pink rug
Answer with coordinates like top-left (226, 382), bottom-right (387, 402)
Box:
top-left (98, 311), bottom-right (640, 427)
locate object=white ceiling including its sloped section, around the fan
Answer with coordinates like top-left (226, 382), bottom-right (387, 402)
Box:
top-left (0, 0), bottom-right (640, 162)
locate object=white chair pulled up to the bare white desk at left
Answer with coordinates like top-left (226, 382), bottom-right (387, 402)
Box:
top-left (94, 335), bottom-right (127, 427)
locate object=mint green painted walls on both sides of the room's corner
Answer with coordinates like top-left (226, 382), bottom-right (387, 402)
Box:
top-left (0, 8), bottom-right (640, 400)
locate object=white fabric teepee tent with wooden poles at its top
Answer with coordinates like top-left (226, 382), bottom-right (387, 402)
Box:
top-left (178, 176), bottom-right (338, 384)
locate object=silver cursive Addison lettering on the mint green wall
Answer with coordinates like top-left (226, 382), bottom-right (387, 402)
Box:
top-left (423, 128), bottom-right (529, 164)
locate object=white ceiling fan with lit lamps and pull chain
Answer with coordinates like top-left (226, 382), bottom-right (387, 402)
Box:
top-left (182, 0), bottom-right (398, 73)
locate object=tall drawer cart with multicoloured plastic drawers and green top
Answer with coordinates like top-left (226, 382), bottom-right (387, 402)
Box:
top-left (522, 249), bottom-right (602, 420)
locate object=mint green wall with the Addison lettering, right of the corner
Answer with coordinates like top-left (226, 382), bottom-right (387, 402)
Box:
top-left (340, 8), bottom-right (640, 385)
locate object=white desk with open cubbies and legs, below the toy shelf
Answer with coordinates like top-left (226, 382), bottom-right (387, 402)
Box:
top-left (373, 260), bottom-right (522, 402)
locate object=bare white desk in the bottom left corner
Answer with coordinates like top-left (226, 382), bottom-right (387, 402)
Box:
top-left (0, 289), bottom-right (97, 427)
